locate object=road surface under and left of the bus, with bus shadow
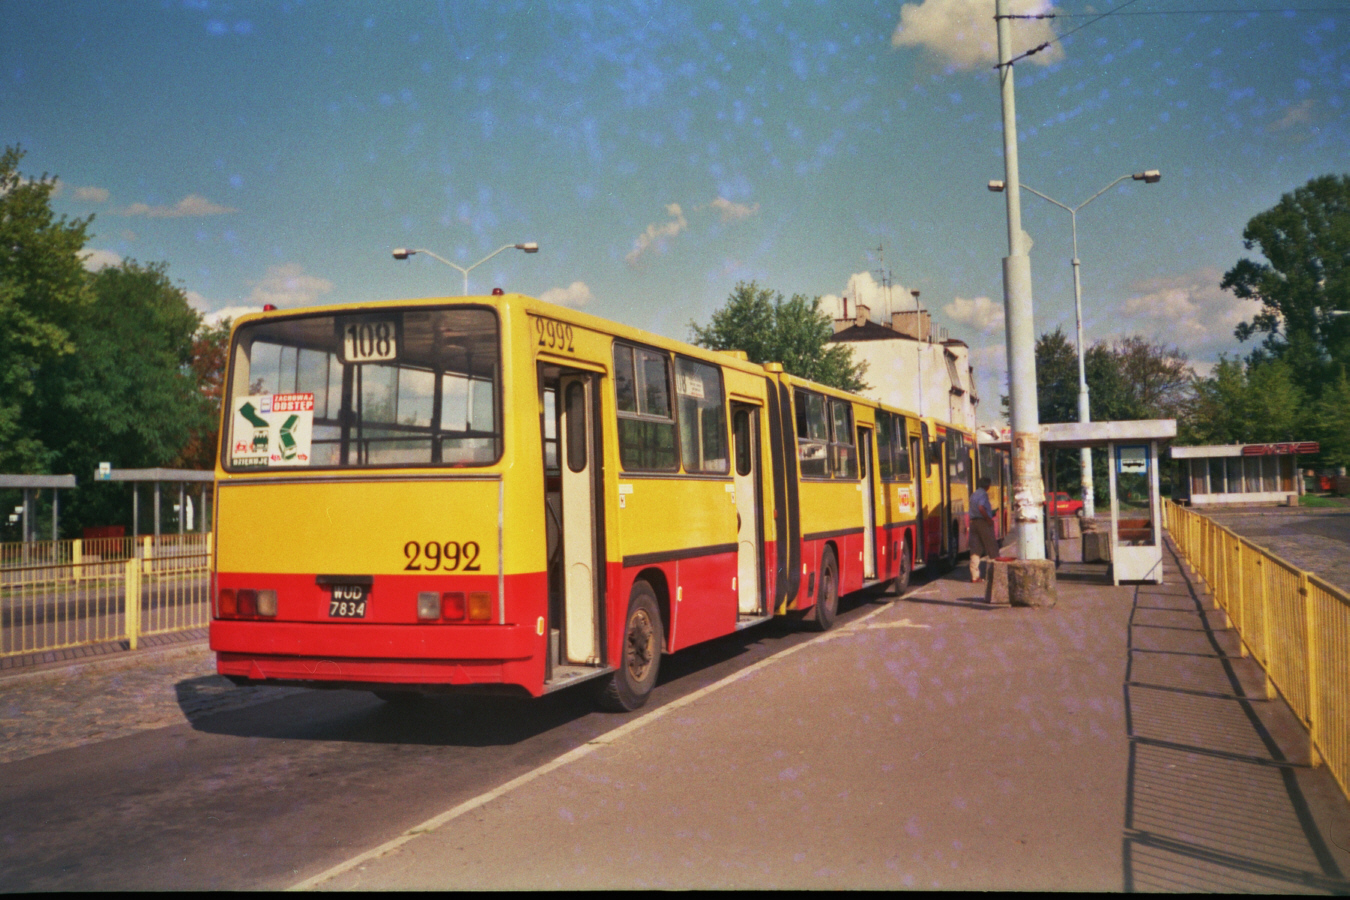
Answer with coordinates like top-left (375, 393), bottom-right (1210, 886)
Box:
top-left (0, 585), bottom-right (869, 892)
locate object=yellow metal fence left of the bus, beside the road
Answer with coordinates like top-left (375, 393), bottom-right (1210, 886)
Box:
top-left (0, 534), bottom-right (212, 657)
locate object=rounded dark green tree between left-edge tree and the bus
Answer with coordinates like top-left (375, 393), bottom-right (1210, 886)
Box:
top-left (32, 260), bottom-right (216, 530)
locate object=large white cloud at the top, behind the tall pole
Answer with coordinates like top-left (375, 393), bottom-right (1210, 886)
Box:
top-left (891, 0), bottom-right (1064, 72)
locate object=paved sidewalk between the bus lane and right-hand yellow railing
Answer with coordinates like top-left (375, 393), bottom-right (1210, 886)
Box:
top-left (306, 542), bottom-right (1350, 893)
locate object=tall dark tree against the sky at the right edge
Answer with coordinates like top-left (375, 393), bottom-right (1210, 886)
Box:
top-left (1222, 175), bottom-right (1350, 395)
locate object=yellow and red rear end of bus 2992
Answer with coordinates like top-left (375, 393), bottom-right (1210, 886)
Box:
top-left (211, 298), bottom-right (547, 694)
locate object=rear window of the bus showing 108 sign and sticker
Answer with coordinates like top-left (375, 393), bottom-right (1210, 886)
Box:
top-left (223, 308), bottom-right (501, 470)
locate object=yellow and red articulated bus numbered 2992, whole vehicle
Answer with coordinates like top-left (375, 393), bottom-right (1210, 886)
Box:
top-left (211, 294), bottom-right (973, 710)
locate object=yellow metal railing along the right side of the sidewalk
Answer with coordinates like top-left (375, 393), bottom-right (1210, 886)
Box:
top-left (1162, 501), bottom-right (1350, 797)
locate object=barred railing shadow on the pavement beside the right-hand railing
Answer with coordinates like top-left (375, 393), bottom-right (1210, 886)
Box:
top-left (1123, 546), bottom-right (1350, 893)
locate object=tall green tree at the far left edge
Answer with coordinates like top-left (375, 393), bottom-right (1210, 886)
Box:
top-left (0, 147), bottom-right (93, 474)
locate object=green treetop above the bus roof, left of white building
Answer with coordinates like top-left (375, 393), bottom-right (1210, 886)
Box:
top-left (689, 282), bottom-right (867, 391)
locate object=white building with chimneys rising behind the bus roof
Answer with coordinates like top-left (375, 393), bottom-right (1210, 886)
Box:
top-left (830, 301), bottom-right (980, 429)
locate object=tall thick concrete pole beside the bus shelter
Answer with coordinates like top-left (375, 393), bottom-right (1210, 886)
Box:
top-left (995, 0), bottom-right (1045, 560)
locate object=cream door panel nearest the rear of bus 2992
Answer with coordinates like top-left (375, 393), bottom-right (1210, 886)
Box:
top-left (551, 374), bottom-right (602, 665)
